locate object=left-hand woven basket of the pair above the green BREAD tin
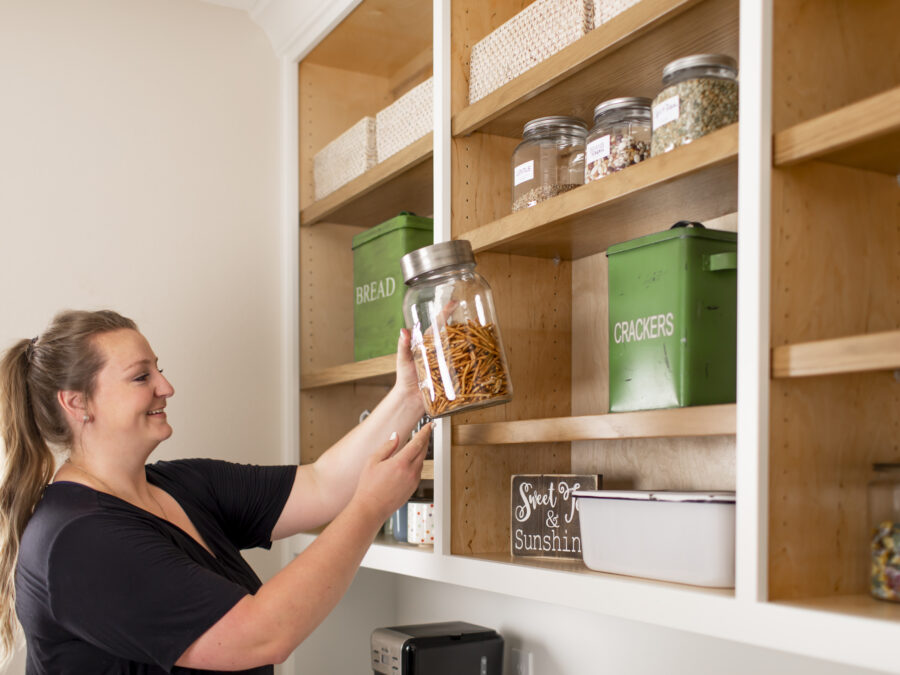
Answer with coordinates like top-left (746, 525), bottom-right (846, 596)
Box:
top-left (313, 117), bottom-right (376, 200)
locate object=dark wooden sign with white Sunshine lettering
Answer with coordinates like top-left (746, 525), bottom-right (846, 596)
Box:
top-left (509, 474), bottom-right (603, 558)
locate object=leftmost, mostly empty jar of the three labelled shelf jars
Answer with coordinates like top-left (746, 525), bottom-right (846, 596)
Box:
top-left (512, 115), bottom-right (587, 211)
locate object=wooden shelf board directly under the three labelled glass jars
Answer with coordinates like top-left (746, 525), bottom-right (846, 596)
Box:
top-left (461, 124), bottom-right (738, 260)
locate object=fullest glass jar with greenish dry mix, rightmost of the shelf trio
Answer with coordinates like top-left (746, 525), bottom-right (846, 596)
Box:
top-left (650, 54), bottom-right (738, 157)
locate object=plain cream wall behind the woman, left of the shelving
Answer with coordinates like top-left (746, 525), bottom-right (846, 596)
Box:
top-left (0, 0), bottom-right (282, 673)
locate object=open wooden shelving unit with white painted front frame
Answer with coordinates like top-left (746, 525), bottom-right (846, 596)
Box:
top-left (300, 0), bottom-right (900, 671)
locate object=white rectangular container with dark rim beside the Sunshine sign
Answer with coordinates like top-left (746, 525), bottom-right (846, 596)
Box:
top-left (574, 490), bottom-right (735, 588)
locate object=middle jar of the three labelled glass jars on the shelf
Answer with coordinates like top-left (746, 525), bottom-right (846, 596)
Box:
top-left (584, 97), bottom-right (651, 183)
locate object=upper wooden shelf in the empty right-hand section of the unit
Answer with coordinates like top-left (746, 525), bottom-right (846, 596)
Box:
top-left (775, 87), bottom-right (900, 176)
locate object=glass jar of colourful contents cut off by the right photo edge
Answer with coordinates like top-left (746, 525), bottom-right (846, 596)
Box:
top-left (869, 464), bottom-right (900, 602)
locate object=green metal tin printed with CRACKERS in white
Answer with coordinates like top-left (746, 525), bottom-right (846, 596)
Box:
top-left (606, 221), bottom-right (737, 412)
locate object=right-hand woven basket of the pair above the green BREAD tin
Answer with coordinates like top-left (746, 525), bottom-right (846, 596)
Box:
top-left (375, 77), bottom-right (434, 162)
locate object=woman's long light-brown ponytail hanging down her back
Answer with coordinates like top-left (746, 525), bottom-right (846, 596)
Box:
top-left (0, 340), bottom-right (54, 668)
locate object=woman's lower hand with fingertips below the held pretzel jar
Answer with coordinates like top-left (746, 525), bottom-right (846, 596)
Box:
top-left (353, 423), bottom-right (434, 521)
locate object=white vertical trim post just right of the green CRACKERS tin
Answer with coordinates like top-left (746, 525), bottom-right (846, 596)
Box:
top-left (735, 0), bottom-right (772, 602)
